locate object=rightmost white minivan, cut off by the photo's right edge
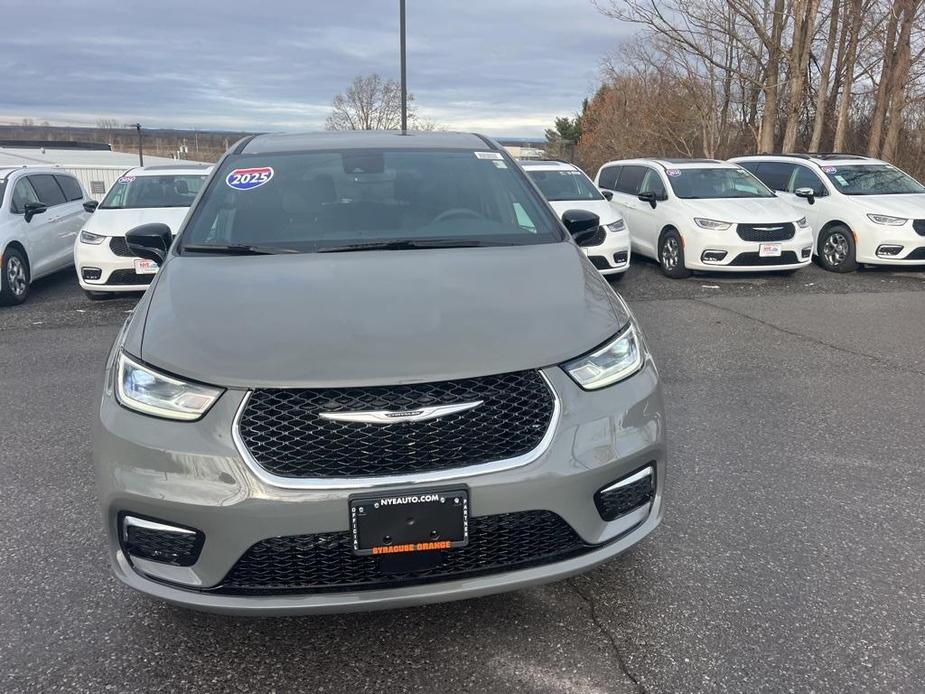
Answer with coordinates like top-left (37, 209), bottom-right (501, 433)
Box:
top-left (732, 154), bottom-right (925, 272)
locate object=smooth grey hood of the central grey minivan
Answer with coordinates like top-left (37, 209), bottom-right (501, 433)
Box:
top-left (125, 242), bottom-right (629, 387)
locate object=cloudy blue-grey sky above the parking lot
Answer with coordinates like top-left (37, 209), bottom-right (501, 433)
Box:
top-left (0, 0), bottom-right (629, 136)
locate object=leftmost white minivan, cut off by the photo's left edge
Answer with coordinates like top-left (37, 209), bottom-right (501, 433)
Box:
top-left (0, 166), bottom-right (88, 305)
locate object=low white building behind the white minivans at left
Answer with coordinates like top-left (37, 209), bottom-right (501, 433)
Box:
top-left (0, 141), bottom-right (210, 200)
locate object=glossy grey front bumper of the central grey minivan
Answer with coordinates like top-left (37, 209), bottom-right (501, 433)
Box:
top-left (94, 360), bottom-right (665, 614)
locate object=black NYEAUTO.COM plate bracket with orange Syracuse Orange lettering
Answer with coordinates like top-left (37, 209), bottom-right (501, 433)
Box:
top-left (349, 488), bottom-right (469, 556)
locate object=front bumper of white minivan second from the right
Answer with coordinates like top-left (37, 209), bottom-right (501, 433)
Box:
top-left (682, 227), bottom-right (813, 272)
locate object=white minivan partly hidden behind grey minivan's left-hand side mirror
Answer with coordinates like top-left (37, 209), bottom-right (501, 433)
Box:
top-left (74, 165), bottom-right (212, 299)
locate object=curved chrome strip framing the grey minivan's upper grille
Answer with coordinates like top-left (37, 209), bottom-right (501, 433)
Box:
top-left (231, 369), bottom-right (562, 490)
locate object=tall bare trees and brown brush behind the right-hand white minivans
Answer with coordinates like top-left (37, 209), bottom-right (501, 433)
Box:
top-left (547, 0), bottom-right (925, 176)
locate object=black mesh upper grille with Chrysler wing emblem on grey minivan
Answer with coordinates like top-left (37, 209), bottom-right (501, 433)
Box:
top-left (238, 371), bottom-right (555, 478)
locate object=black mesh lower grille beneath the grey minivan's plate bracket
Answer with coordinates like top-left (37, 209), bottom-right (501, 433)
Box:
top-left (215, 511), bottom-right (594, 594)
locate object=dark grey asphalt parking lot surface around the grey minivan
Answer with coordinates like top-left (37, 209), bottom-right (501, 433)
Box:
top-left (0, 261), bottom-right (925, 692)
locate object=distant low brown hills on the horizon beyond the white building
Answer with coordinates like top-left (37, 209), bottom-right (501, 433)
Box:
top-left (0, 125), bottom-right (252, 161)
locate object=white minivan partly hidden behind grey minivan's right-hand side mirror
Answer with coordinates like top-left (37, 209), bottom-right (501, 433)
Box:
top-left (520, 161), bottom-right (630, 279)
